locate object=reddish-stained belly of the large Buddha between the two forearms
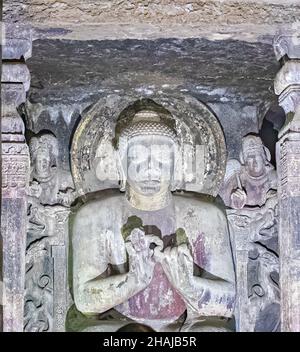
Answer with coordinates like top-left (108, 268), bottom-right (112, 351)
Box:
top-left (116, 263), bottom-right (186, 320)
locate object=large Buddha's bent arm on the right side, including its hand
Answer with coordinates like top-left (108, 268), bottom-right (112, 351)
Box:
top-left (162, 211), bottom-right (235, 317)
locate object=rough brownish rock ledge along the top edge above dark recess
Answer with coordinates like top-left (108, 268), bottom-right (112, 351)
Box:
top-left (4, 0), bottom-right (300, 40)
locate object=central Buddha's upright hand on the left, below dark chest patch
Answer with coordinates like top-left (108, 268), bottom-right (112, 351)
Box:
top-left (125, 228), bottom-right (163, 289)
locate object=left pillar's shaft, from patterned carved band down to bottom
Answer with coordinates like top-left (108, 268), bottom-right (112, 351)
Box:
top-left (1, 142), bottom-right (29, 331)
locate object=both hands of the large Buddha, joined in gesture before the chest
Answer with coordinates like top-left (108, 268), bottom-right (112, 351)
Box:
top-left (125, 228), bottom-right (194, 287)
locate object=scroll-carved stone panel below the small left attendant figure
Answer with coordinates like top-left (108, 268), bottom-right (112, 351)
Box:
top-left (24, 197), bottom-right (70, 332)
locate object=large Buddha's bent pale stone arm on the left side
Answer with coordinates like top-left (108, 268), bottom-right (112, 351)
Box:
top-left (72, 210), bottom-right (152, 314)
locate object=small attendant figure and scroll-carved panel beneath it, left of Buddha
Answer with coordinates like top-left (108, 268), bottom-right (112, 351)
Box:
top-left (24, 133), bottom-right (74, 331)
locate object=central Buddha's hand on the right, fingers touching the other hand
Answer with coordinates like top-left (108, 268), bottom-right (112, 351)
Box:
top-left (155, 243), bottom-right (194, 292)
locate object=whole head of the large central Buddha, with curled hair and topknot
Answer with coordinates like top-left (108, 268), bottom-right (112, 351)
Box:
top-left (118, 110), bottom-right (178, 196)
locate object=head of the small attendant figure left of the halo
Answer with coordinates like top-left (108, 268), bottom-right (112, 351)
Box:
top-left (29, 134), bottom-right (58, 181)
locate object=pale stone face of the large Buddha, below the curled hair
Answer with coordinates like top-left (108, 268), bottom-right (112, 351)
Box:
top-left (126, 135), bottom-right (175, 196)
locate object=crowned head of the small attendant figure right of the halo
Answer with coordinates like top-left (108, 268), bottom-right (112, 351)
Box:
top-left (240, 135), bottom-right (271, 177)
